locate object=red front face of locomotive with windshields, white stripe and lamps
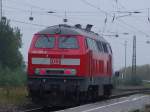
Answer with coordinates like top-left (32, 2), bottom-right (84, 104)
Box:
top-left (28, 34), bottom-right (85, 77)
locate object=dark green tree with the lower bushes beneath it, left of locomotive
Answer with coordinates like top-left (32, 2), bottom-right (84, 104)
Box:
top-left (0, 20), bottom-right (26, 87)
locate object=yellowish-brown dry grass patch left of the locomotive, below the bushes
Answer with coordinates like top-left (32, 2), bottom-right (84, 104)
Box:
top-left (0, 87), bottom-right (28, 105)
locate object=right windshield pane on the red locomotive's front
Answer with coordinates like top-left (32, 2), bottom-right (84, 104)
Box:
top-left (58, 37), bottom-right (79, 49)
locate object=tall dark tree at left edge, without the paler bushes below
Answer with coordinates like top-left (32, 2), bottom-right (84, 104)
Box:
top-left (0, 20), bottom-right (23, 70)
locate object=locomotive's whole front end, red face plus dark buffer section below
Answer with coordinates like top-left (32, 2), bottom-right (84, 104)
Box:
top-left (28, 34), bottom-right (86, 102)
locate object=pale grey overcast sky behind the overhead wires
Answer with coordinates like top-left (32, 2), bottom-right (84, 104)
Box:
top-left (3, 0), bottom-right (150, 69)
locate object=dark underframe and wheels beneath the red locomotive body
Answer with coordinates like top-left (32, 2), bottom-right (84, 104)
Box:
top-left (28, 76), bottom-right (112, 104)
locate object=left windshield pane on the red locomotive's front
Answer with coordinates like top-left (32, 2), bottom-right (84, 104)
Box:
top-left (35, 36), bottom-right (55, 48)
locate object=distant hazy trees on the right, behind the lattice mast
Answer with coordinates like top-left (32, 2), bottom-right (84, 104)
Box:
top-left (113, 64), bottom-right (150, 85)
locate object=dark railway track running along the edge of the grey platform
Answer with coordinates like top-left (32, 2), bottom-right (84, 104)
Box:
top-left (19, 88), bottom-right (150, 112)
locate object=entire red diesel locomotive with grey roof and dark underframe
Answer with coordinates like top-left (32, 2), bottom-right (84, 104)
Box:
top-left (27, 24), bottom-right (112, 102)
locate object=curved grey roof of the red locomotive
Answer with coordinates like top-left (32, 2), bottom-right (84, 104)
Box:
top-left (37, 24), bottom-right (107, 42)
